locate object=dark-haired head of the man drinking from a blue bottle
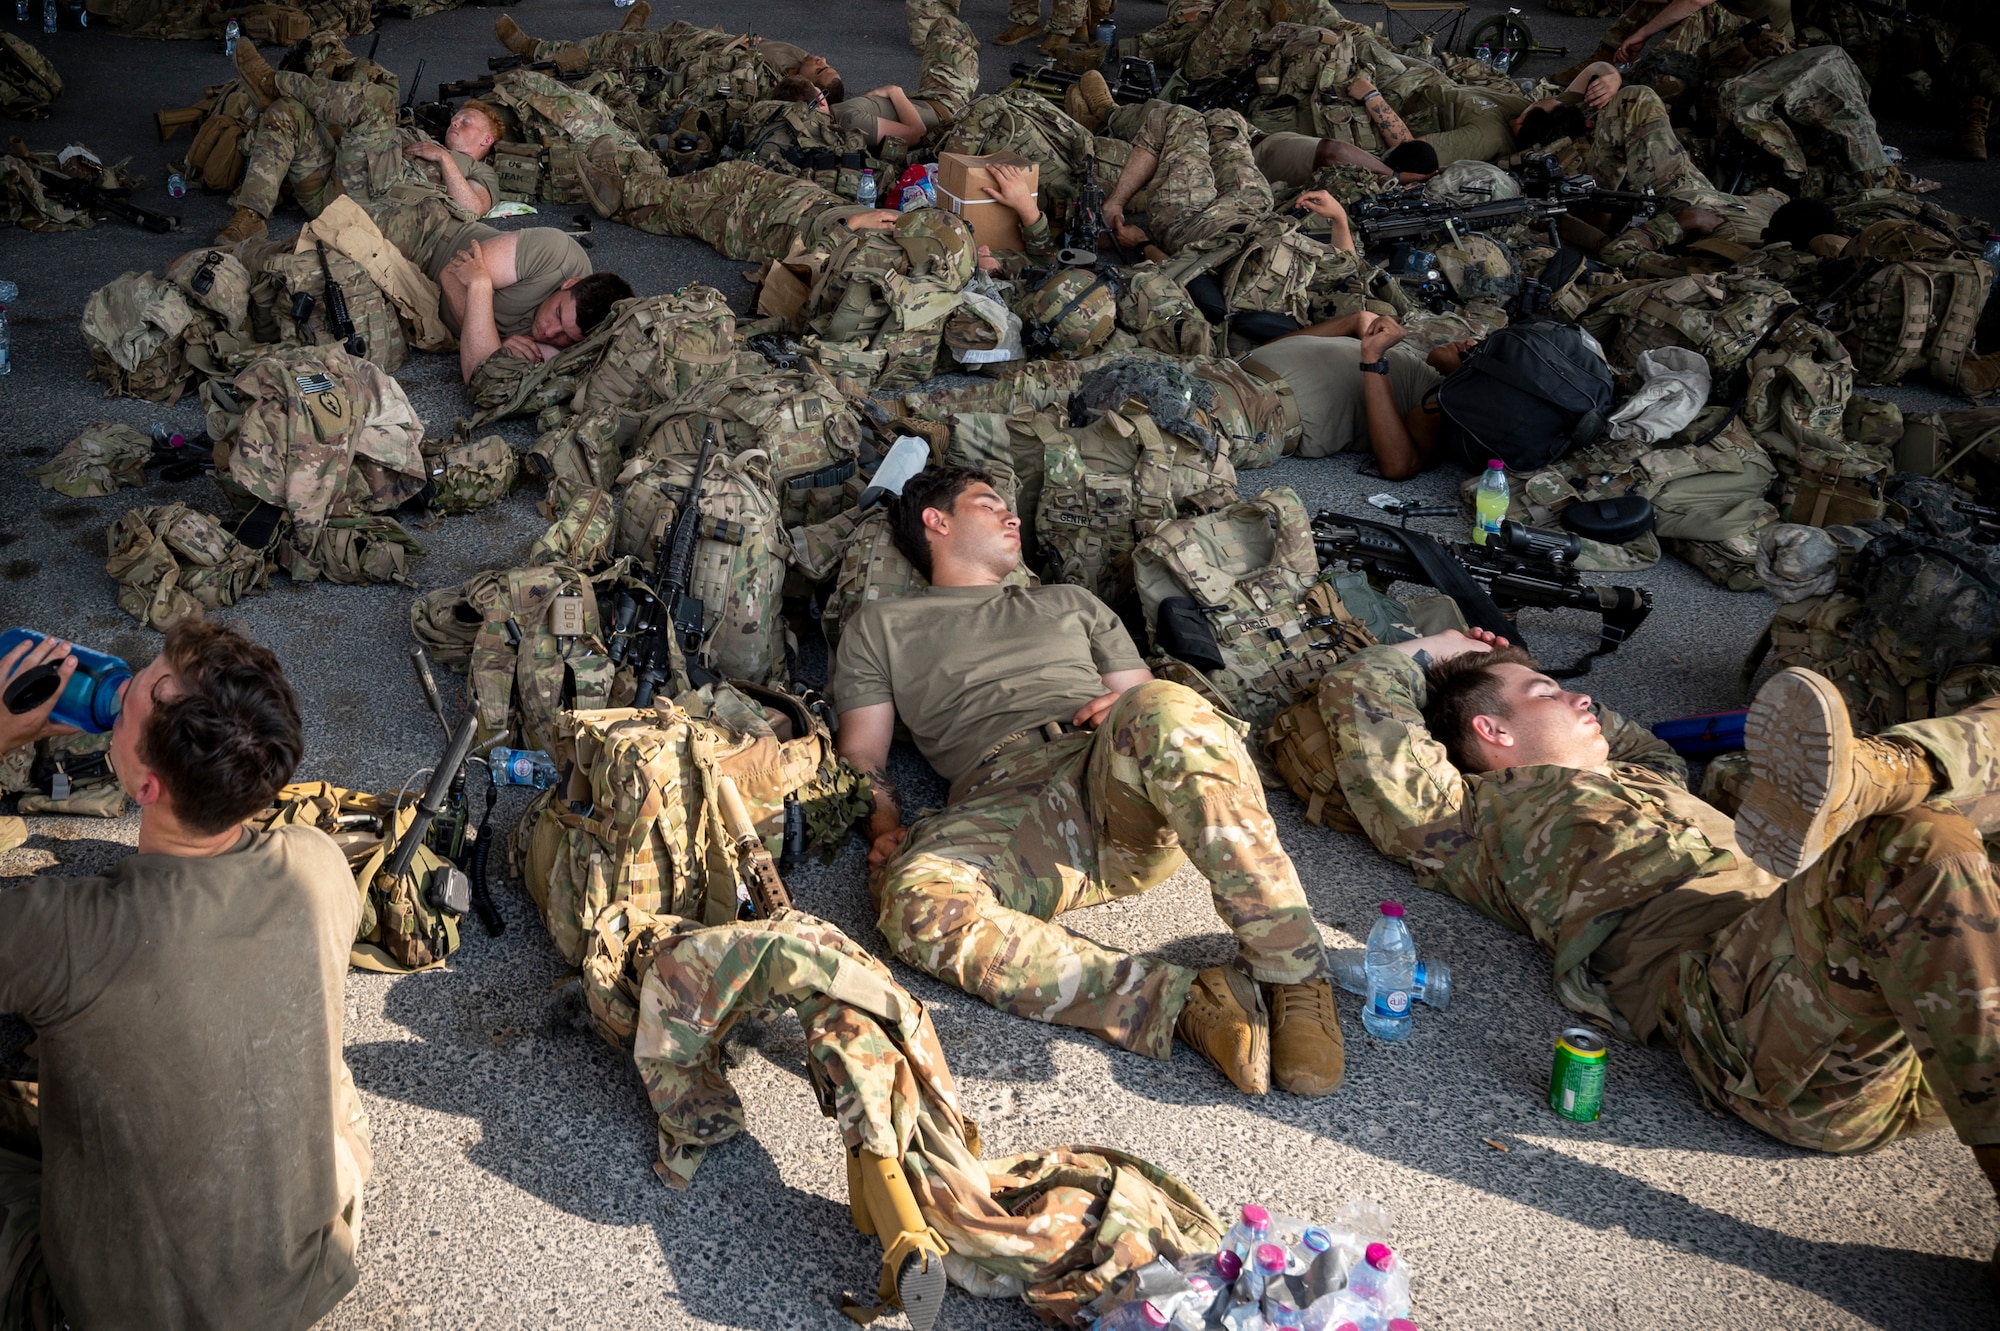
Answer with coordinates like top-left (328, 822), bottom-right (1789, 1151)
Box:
top-left (110, 620), bottom-right (306, 851)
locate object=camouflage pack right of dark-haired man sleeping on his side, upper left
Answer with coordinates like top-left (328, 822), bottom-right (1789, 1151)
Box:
top-left (570, 282), bottom-right (736, 414)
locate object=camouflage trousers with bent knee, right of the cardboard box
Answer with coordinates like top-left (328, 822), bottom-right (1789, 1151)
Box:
top-left (1104, 102), bottom-right (1272, 254)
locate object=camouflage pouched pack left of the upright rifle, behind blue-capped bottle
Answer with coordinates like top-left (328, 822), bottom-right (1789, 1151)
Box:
top-left (410, 564), bottom-right (612, 753)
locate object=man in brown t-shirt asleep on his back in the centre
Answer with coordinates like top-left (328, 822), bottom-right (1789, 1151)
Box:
top-left (832, 468), bottom-right (1342, 1095)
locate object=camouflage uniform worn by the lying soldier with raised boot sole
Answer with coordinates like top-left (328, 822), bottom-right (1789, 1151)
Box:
top-left (1320, 648), bottom-right (2000, 1151)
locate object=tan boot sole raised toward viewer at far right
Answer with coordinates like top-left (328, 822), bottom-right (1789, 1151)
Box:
top-left (1736, 667), bottom-right (1854, 879)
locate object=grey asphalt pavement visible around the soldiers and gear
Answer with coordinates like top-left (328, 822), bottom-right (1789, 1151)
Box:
top-left (0, 0), bottom-right (2000, 1331)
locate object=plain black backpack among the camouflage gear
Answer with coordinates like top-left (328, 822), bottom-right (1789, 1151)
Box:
top-left (1438, 322), bottom-right (1618, 472)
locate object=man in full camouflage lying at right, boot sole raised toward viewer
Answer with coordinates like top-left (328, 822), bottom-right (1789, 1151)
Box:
top-left (1318, 634), bottom-right (2000, 1271)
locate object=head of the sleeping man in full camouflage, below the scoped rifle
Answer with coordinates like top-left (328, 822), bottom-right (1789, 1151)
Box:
top-left (1418, 634), bottom-right (1610, 771)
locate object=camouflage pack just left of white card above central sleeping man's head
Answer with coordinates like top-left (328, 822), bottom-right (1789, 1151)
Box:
top-left (640, 370), bottom-right (860, 528)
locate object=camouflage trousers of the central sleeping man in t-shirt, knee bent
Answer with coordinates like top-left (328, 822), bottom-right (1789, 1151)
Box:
top-left (872, 681), bottom-right (1324, 1059)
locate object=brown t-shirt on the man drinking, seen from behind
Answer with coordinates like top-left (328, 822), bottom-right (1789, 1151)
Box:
top-left (0, 827), bottom-right (360, 1331)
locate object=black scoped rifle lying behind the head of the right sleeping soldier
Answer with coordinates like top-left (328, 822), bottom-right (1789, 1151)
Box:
top-left (1312, 504), bottom-right (1652, 679)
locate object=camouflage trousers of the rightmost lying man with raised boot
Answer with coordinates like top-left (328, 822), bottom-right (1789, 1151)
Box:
top-left (1660, 703), bottom-right (2000, 1153)
